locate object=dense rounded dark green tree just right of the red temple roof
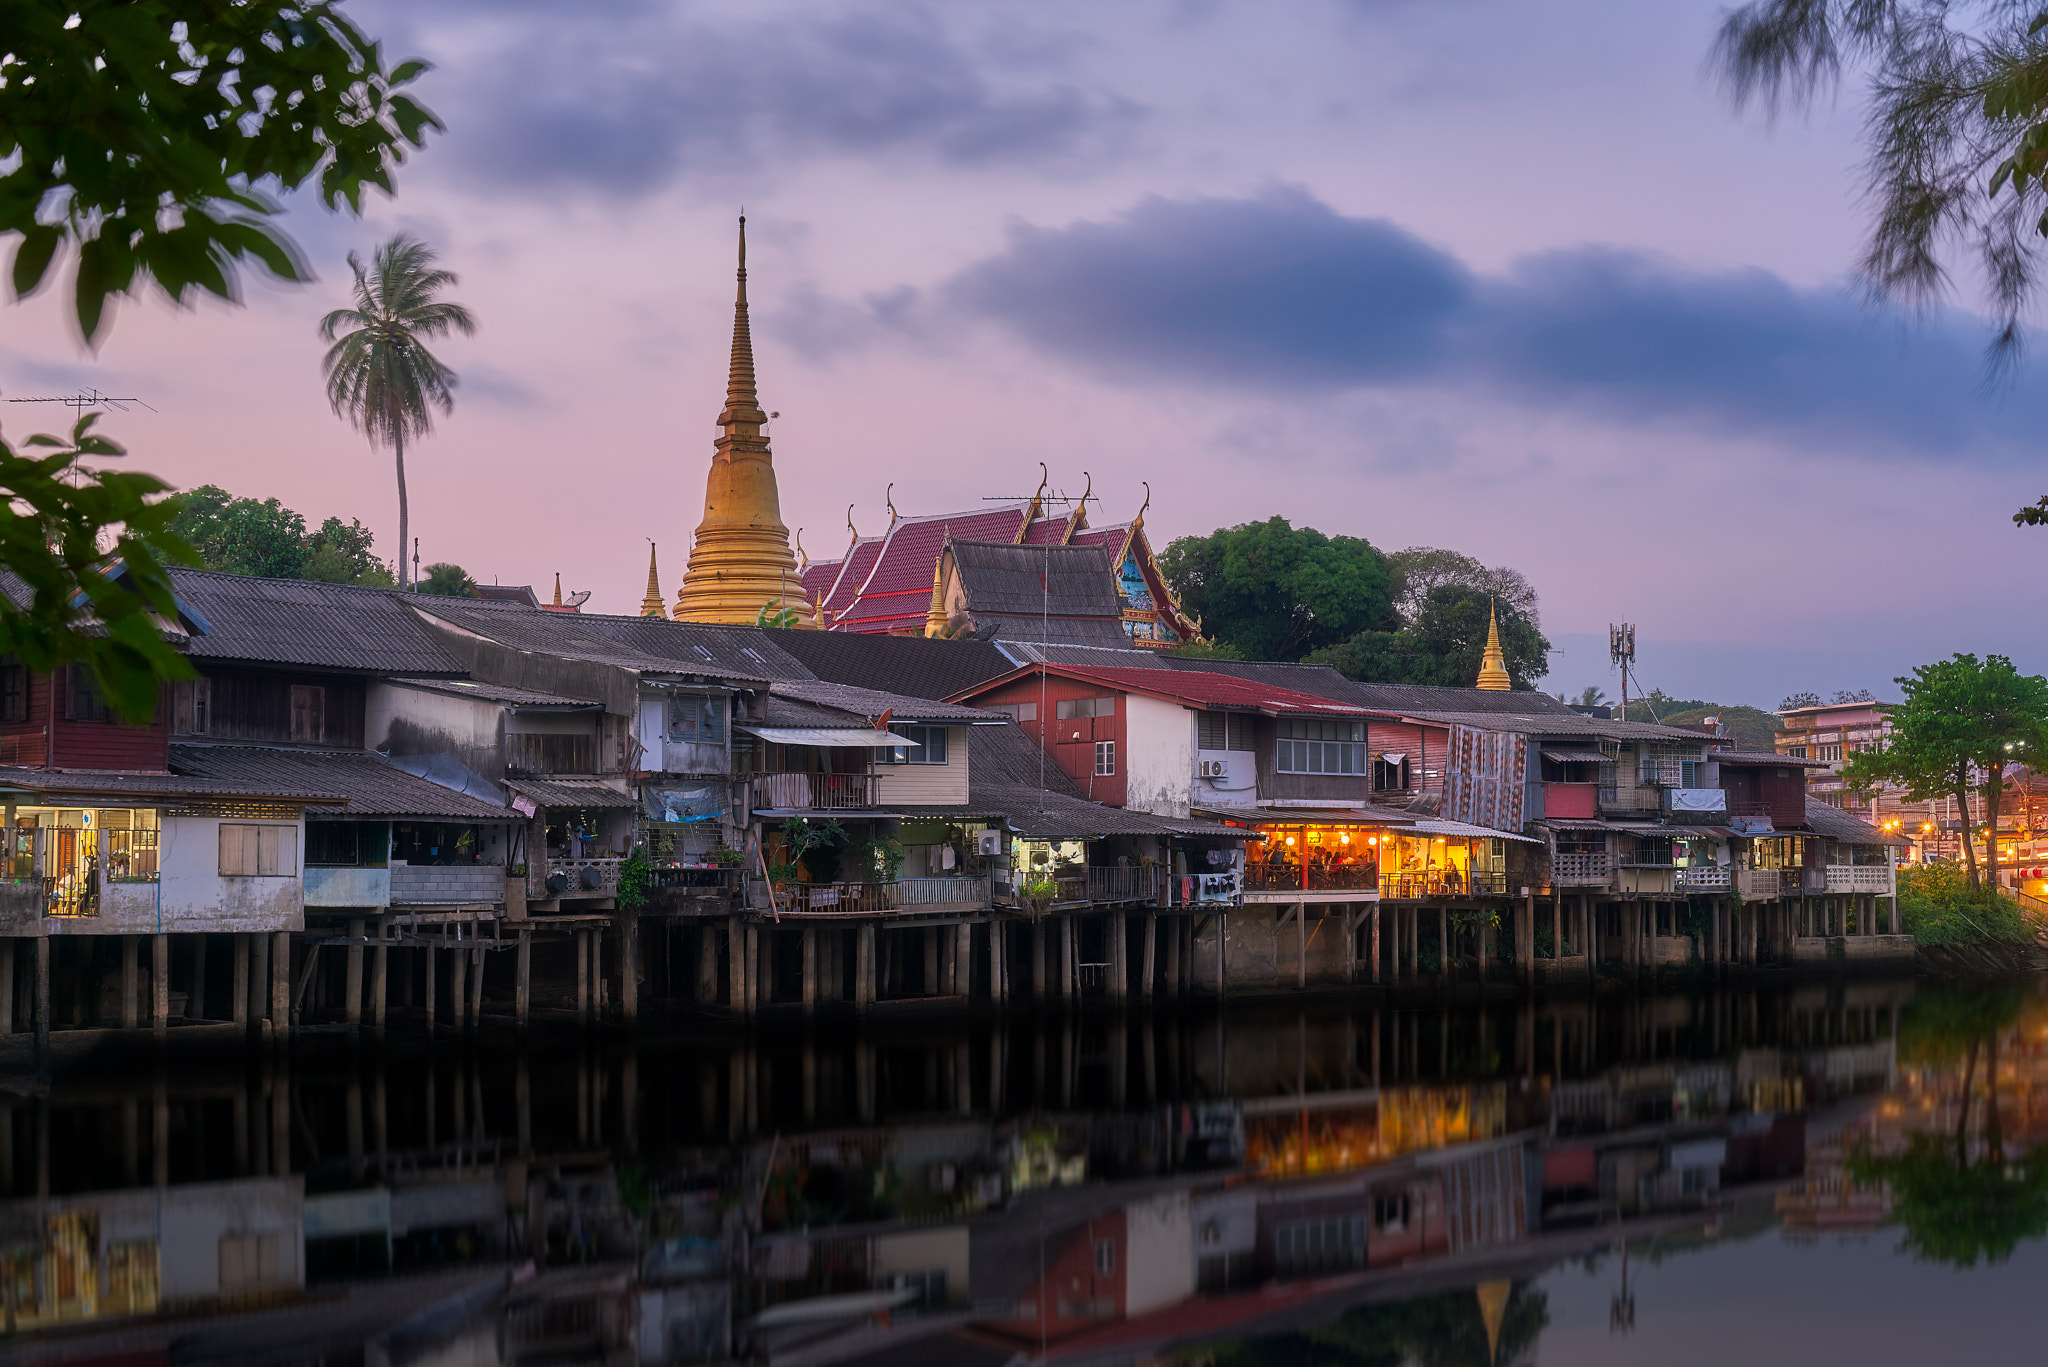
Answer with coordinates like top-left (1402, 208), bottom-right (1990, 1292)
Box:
top-left (1159, 516), bottom-right (1397, 660)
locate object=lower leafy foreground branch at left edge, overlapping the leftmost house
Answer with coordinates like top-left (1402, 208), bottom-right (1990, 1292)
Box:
top-left (0, 414), bottom-right (197, 721)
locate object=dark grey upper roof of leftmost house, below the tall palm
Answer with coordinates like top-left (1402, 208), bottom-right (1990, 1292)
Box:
top-left (170, 570), bottom-right (463, 674)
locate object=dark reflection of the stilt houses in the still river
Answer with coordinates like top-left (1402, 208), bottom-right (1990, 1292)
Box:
top-left (0, 982), bottom-right (2048, 1365)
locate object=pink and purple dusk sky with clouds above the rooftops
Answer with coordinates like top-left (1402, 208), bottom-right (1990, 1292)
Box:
top-left (0, 0), bottom-right (2048, 707)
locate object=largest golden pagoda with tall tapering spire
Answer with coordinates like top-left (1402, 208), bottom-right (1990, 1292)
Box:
top-left (649, 215), bottom-right (817, 627)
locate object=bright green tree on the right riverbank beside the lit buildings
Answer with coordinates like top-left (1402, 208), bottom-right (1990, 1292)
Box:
top-left (1843, 654), bottom-right (2048, 889)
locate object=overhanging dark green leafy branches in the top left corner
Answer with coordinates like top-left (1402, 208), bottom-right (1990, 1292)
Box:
top-left (0, 0), bottom-right (440, 342)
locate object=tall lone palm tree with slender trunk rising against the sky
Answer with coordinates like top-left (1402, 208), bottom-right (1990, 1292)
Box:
top-left (319, 234), bottom-right (477, 588)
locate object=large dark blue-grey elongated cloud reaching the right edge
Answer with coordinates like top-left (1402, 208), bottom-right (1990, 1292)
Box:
top-left (940, 189), bottom-right (2048, 459)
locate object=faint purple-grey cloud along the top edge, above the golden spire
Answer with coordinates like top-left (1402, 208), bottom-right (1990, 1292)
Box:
top-left (399, 4), bottom-right (1139, 193)
